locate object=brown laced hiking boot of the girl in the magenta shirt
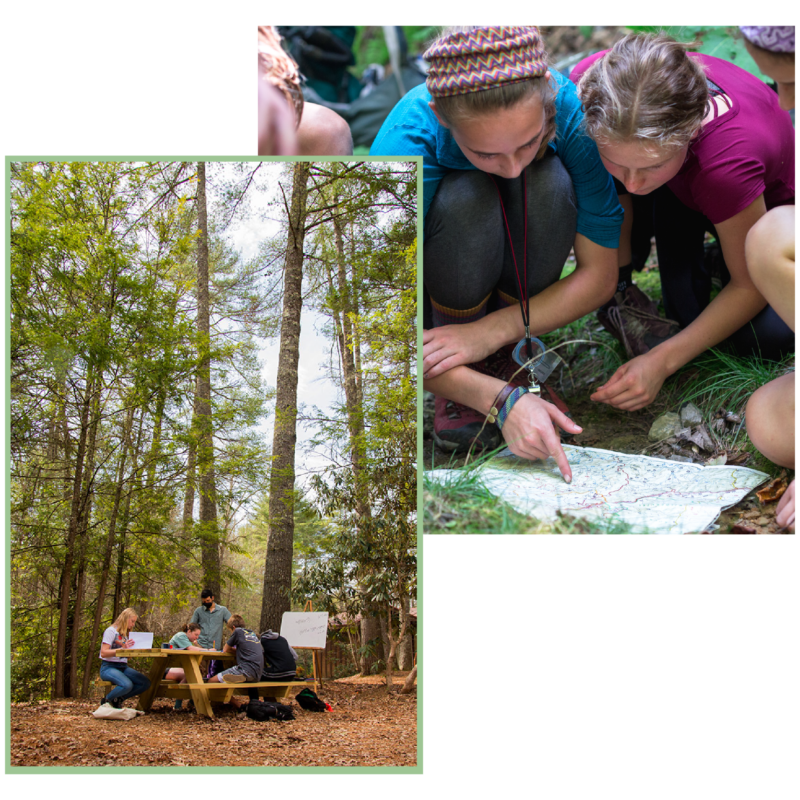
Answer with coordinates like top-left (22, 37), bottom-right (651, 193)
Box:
top-left (597, 286), bottom-right (680, 358)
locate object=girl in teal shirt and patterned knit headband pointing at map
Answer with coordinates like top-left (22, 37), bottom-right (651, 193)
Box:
top-left (370, 25), bottom-right (623, 480)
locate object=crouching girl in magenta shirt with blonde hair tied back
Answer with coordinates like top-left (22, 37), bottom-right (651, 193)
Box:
top-left (571, 34), bottom-right (796, 411)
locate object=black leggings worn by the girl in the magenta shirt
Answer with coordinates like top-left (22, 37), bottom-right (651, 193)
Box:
top-left (614, 178), bottom-right (797, 359)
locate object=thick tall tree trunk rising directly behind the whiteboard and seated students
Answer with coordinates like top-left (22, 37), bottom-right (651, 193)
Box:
top-left (261, 161), bottom-right (311, 631)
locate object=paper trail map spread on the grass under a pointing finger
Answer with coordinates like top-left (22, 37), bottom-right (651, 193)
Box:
top-left (425, 445), bottom-right (769, 536)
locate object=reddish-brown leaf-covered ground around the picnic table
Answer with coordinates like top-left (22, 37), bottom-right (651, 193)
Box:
top-left (10, 672), bottom-right (417, 767)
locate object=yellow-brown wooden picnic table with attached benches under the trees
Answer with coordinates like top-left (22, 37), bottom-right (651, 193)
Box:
top-left (98, 647), bottom-right (317, 719)
